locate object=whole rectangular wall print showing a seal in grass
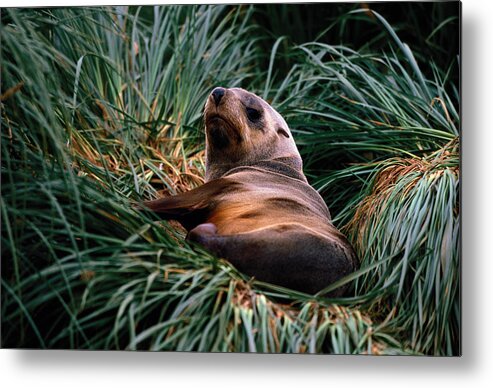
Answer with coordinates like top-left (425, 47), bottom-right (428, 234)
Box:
top-left (0, 1), bottom-right (462, 358)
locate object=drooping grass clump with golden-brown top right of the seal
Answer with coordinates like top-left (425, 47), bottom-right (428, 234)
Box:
top-left (347, 141), bottom-right (460, 354)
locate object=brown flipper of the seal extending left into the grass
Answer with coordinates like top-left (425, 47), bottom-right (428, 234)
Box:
top-left (142, 178), bottom-right (237, 230)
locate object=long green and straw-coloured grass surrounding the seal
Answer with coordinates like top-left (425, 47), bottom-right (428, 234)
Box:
top-left (1, 6), bottom-right (460, 355)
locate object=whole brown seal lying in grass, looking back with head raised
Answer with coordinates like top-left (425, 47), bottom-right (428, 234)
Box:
top-left (144, 87), bottom-right (357, 296)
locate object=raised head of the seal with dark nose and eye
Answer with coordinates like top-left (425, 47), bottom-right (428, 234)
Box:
top-left (204, 87), bottom-right (302, 182)
